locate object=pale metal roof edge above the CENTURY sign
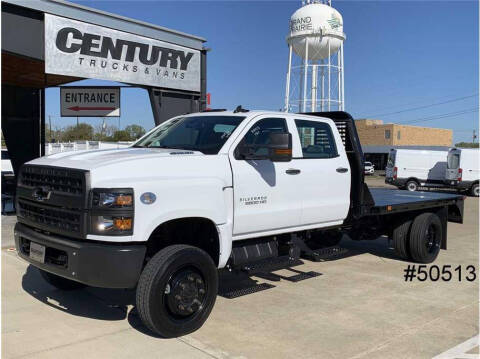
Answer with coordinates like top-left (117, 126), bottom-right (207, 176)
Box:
top-left (2, 0), bottom-right (206, 50)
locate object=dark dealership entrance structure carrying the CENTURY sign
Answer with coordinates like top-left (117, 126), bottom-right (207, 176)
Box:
top-left (2, 0), bottom-right (207, 176)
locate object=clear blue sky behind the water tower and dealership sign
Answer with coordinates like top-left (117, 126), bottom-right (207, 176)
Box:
top-left (46, 0), bottom-right (479, 142)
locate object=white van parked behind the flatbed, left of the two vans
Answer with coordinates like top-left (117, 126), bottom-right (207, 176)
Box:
top-left (385, 149), bottom-right (448, 191)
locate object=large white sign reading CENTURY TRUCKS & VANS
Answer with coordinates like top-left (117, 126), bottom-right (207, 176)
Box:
top-left (45, 14), bottom-right (200, 92)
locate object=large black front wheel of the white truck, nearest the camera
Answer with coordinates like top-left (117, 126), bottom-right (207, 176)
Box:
top-left (136, 244), bottom-right (218, 338)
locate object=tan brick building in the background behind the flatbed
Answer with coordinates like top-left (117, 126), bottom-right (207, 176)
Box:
top-left (355, 119), bottom-right (453, 170)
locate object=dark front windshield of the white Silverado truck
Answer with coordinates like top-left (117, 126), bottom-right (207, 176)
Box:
top-left (133, 116), bottom-right (245, 155)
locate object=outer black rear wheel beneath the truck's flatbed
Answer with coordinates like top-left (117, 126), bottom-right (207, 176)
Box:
top-left (409, 213), bottom-right (443, 263)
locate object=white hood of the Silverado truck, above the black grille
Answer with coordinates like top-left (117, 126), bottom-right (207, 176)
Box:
top-left (29, 147), bottom-right (204, 170)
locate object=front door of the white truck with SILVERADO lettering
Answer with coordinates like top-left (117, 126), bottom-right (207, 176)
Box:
top-left (230, 117), bottom-right (301, 235)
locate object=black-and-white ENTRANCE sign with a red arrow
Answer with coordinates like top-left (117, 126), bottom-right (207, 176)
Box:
top-left (60, 87), bottom-right (120, 117)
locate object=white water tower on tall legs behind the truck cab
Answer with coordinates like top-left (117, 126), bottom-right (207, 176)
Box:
top-left (285, 0), bottom-right (345, 112)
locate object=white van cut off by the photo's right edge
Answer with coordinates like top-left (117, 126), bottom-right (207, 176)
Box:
top-left (445, 148), bottom-right (480, 197)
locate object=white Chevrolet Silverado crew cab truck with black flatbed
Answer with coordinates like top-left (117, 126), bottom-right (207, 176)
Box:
top-left (15, 108), bottom-right (464, 337)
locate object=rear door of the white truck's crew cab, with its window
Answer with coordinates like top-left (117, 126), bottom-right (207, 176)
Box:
top-left (292, 116), bottom-right (351, 226)
